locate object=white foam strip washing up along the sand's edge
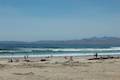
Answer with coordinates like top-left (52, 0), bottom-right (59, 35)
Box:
top-left (0, 53), bottom-right (120, 58)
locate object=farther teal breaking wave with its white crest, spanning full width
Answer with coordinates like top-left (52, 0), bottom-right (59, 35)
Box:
top-left (0, 47), bottom-right (120, 53)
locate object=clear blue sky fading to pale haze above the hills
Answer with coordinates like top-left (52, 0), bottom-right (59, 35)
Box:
top-left (0, 0), bottom-right (120, 41)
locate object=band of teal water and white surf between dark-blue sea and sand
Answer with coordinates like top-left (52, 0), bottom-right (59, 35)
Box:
top-left (0, 47), bottom-right (120, 58)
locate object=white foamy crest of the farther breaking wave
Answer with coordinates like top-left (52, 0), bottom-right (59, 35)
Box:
top-left (18, 47), bottom-right (120, 51)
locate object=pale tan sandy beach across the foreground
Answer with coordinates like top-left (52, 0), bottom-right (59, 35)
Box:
top-left (0, 57), bottom-right (120, 80)
